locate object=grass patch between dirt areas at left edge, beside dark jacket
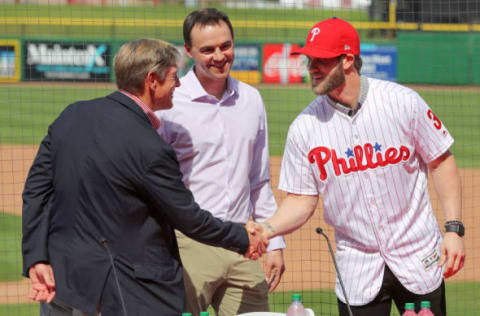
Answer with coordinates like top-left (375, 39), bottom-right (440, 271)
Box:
top-left (0, 212), bottom-right (22, 282)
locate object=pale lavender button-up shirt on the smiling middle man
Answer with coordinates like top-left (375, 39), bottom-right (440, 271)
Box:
top-left (155, 68), bottom-right (285, 250)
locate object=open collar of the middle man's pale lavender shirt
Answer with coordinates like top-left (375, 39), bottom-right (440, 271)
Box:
top-left (181, 66), bottom-right (238, 104)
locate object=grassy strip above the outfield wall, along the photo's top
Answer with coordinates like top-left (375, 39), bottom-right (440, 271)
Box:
top-left (0, 4), bottom-right (372, 42)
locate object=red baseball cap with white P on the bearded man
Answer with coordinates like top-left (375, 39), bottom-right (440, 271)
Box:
top-left (291, 18), bottom-right (360, 58)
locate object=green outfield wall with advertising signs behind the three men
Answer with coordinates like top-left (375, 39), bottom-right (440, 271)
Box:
top-left (0, 31), bottom-right (480, 85)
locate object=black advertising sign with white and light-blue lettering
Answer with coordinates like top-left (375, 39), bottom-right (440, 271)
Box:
top-left (24, 41), bottom-right (111, 81)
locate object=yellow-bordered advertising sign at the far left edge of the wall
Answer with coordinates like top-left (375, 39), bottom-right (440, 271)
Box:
top-left (0, 40), bottom-right (20, 82)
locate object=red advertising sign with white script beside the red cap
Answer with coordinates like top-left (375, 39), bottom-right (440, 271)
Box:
top-left (262, 43), bottom-right (308, 83)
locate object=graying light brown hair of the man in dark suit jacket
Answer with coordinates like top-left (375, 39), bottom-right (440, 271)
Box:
top-left (113, 38), bottom-right (178, 94)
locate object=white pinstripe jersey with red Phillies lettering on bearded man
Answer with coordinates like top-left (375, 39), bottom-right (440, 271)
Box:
top-left (279, 77), bottom-right (453, 305)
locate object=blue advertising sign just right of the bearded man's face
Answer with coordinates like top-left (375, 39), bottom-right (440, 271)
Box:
top-left (360, 43), bottom-right (397, 81)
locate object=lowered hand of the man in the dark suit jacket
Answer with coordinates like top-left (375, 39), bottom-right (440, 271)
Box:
top-left (28, 263), bottom-right (55, 303)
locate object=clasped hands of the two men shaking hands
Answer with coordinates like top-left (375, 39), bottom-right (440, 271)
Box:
top-left (244, 221), bottom-right (275, 260)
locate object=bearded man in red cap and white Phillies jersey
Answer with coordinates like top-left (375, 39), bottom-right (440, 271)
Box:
top-left (258, 18), bottom-right (465, 316)
